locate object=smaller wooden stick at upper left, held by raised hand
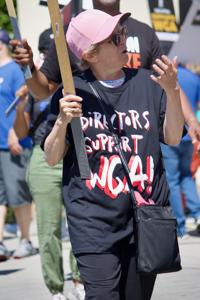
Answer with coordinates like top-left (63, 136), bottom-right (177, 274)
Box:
top-left (6, 0), bottom-right (32, 79)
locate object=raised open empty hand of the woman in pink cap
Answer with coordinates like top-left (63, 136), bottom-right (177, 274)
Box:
top-left (150, 55), bottom-right (179, 92)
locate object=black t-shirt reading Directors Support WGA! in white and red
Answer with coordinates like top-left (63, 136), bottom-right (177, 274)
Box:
top-left (44, 69), bottom-right (169, 253)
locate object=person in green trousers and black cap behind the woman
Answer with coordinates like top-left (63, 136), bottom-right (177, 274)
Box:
top-left (14, 29), bottom-right (66, 300)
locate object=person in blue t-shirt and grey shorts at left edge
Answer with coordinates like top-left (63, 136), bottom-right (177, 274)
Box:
top-left (0, 29), bottom-right (36, 261)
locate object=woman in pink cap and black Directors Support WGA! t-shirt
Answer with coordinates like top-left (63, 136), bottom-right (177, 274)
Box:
top-left (44, 10), bottom-right (184, 300)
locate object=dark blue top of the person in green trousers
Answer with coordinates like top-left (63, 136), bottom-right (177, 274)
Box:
top-left (25, 95), bottom-right (51, 145)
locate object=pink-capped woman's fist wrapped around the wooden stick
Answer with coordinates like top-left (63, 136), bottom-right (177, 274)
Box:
top-left (59, 94), bottom-right (83, 124)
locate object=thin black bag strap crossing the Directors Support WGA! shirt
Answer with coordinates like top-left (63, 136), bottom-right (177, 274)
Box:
top-left (88, 82), bottom-right (138, 216)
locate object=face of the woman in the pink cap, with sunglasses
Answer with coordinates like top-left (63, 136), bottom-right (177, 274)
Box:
top-left (96, 25), bottom-right (128, 71)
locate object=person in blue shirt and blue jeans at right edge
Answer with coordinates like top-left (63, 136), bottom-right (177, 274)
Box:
top-left (162, 64), bottom-right (200, 237)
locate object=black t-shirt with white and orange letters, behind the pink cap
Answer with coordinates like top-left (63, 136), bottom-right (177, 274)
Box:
top-left (40, 18), bottom-right (162, 84)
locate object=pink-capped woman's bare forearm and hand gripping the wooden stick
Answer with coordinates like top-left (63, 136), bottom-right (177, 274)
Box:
top-left (44, 95), bottom-right (82, 166)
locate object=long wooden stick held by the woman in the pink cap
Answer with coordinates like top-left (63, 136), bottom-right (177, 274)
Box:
top-left (48, 0), bottom-right (90, 179)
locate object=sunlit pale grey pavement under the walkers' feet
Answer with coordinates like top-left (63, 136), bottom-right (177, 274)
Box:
top-left (0, 222), bottom-right (200, 300)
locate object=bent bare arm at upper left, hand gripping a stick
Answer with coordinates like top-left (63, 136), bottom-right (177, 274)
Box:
top-left (10, 40), bottom-right (58, 99)
